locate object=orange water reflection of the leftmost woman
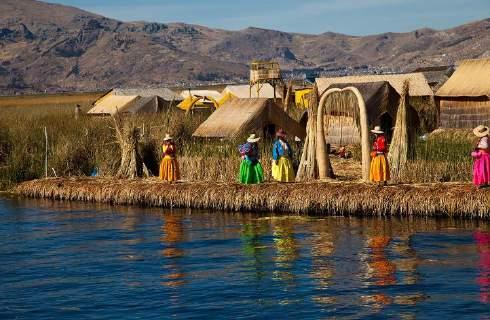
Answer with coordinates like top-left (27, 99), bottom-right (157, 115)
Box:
top-left (161, 213), bottom-right (184, 287)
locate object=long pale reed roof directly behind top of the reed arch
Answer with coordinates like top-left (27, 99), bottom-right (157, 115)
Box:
top-left (316, 72), bottom-right (434, 97)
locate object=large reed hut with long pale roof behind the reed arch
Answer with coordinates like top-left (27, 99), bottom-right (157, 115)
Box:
top-left (316, 73), bottom-right (438, 144)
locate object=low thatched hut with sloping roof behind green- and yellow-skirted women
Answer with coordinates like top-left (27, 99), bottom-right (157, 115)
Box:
top-left (193, 98), bottom-right (306, 139)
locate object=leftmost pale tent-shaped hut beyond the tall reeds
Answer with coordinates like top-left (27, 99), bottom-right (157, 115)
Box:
top-left (88, 88), bottom-right (182, 115)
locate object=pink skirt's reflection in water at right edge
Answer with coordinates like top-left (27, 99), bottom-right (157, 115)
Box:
top-left (474, 230), bottom-right (490, 303)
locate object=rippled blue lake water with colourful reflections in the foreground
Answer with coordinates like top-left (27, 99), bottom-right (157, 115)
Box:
top-left (0, 197), bottom-right (490, 319)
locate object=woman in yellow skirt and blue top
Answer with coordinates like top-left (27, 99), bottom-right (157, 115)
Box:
top-left (272, 129), bottom-right (295, 182)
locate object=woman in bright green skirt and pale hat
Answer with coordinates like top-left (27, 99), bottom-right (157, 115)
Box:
top-left (239, 134), bottom-right (264, 184)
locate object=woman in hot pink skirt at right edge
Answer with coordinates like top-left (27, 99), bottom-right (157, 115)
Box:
top-left (471, 126), bottom-right (490, 188)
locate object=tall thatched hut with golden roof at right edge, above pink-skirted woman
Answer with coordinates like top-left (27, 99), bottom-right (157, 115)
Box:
top-left (436, 58), bottom-right (490, 128)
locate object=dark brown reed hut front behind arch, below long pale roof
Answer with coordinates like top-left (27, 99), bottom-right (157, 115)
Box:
top-left (324, 81), bottom-right (400, 145)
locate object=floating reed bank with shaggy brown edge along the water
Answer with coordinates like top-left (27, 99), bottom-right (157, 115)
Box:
top-left (14, 177), bottom-right (490, 219)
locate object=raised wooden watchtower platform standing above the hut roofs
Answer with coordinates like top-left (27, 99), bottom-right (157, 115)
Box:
top-left (250, 61), bottom-right (284, 99)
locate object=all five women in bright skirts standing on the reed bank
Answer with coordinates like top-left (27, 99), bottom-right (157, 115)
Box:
top-left (160, 125), bottom-right (490, 188)
